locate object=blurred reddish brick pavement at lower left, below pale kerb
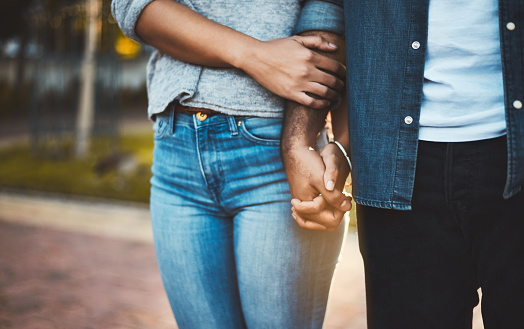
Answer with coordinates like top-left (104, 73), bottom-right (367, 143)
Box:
top-left (0, 221), bottom-right (176, 329)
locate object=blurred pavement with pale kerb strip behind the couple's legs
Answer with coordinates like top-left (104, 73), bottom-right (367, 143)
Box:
top-left (0, 192), bottom-right (482, 329)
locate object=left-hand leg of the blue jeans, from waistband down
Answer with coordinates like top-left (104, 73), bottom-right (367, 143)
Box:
top-left (151, 112), bottom-right (245, 329)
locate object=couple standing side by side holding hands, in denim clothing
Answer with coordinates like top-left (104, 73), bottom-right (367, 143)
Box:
top-left (112, 0), bottom-right (524, 329)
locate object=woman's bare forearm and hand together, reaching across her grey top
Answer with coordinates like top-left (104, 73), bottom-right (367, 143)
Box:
top-left (133, 0), bottom-right (345, 109)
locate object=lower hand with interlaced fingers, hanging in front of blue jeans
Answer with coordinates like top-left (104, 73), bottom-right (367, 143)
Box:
top-left (284, 147), bottom-right (351, 231)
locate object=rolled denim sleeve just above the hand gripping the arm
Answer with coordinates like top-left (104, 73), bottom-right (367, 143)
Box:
top-left (294, 0), bottom-right (344, 36)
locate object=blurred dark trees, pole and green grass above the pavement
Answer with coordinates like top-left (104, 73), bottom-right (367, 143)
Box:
top-left (0, 0), bottom-right (152, 202)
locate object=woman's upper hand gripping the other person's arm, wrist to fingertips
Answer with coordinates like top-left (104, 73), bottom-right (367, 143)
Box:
top-left (238, 36), bottom-right (346, 109)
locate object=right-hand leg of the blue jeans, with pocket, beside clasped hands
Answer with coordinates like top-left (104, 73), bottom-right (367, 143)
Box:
top-left (221, 118), bottom-right (346, 329)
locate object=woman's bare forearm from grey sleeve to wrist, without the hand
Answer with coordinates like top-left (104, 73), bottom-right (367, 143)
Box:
top-left (136, 0), bottom-right (260, 67)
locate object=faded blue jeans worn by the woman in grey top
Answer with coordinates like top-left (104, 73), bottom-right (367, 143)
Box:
top-left (151, 110), bottom-right (345, 329)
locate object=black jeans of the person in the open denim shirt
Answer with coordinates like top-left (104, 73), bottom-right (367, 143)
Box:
top-left (357, 136), bottom-right (524, 329)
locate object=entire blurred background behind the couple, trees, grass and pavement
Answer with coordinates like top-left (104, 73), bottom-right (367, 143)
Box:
top-left (0, 0), bottom-right (482, 329)
